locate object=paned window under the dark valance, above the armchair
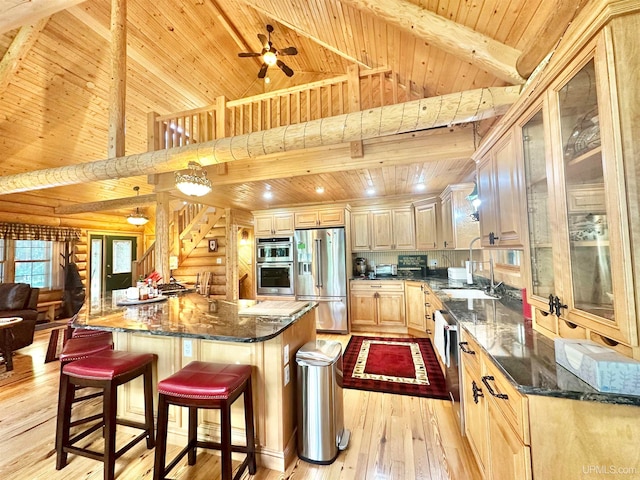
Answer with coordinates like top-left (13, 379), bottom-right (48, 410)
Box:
top-left (14, 240), bottom-right (53, 288)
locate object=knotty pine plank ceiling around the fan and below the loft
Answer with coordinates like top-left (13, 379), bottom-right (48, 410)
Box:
top-left (0, 0), bottom-right (584, 218)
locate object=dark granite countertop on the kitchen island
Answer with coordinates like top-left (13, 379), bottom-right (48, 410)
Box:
top-left (73, 290), bottom-right (317, 343)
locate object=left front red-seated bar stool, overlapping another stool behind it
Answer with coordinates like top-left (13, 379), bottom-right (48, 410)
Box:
top-left (56, 348), bottom-right (156, 480)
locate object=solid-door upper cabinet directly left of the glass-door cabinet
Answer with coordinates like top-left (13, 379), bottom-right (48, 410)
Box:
top-left (478, 132), bottom-right (524, 248)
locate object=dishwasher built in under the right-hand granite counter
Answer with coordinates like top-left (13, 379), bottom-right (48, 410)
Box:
top-left (434, 310), bottom-right (464, 435)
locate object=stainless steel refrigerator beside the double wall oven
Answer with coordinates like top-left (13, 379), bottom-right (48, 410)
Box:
top-left (295, 228), bottom-right (349, 333)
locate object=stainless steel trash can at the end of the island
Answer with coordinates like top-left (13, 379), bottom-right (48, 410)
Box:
top-left (296, 340), bottom-right (350, 465)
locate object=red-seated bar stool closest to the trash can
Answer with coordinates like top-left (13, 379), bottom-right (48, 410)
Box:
top-left (153, 362), bottom-right (256, 480)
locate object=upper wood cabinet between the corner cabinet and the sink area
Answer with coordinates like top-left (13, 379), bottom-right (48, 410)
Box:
top-left (440, 183), bottom-right (480, 249)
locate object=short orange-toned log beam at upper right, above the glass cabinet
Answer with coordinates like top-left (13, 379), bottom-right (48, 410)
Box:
top-left (516, 0), bottom-right (589, 78)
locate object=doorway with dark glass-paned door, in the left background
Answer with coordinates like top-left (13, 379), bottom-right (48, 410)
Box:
top-left (89, 234), bottom-right (138, 303)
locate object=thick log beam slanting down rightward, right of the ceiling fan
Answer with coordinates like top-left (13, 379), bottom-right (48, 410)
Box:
top-left (341, 0), bottom-right (525, 85)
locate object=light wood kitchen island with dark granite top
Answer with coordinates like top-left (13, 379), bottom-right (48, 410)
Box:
top-left (73, 291), bottom-right (317, 471)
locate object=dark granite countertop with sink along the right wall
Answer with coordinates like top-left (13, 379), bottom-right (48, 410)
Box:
top-left (425, 278), bottom-right (640, 406)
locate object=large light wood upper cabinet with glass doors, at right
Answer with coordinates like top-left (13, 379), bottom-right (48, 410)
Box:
top-left (475, 1), bottom-right (640, 359)
